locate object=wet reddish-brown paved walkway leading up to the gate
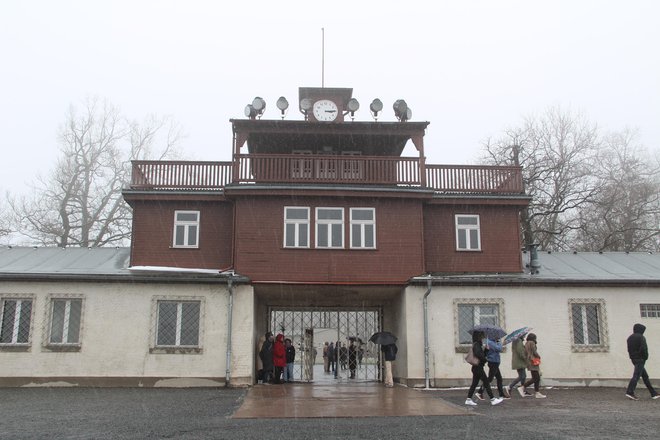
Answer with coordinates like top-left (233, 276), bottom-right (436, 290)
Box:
top-left (232, 382), bottom-right (471, 419)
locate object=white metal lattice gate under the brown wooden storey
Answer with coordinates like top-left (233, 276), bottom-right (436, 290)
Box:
top-left (269, 307), bottom-right (381, 382)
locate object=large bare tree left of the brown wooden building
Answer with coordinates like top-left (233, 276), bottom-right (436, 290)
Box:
top-left (8, 98), bottom-right (180, 247)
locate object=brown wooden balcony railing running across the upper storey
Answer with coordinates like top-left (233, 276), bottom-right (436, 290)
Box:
top-left (130, 154), bottom-right (523, 194)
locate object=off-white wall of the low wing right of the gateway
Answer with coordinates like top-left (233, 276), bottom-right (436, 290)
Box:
top-left (402, 286), bottom-right (660, 384)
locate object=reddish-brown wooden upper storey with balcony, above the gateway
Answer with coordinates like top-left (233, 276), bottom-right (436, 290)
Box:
top-left (124, 87), bottom-right (528, 285)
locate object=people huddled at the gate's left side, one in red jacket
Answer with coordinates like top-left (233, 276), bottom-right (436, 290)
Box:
top-left (259, 332), bottom-right (296, 384)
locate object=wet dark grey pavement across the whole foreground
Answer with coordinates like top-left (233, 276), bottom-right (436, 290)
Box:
top-left (0, 383), bottom-right (660, 440)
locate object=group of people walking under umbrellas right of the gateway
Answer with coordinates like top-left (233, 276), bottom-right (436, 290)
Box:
top-left (465, 331), bottom-right (546, 406)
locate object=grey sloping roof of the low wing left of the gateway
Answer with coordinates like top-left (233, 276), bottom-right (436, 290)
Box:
top-left (0, 247), bottom-right (245, 282)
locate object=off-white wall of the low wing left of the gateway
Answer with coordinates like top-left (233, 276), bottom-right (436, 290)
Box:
top-left (0, 282), bottom-right (254, 386)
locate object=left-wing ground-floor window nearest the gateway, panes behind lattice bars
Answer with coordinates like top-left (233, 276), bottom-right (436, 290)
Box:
top-left (156, 300), bottom-right (201, 347)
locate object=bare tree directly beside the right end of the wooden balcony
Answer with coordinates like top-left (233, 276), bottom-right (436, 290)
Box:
top-left (484, 107), bottom-right (600, 250)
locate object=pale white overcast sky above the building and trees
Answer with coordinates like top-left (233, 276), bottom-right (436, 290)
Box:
top-left (0, 0), bottom-right (660, 192)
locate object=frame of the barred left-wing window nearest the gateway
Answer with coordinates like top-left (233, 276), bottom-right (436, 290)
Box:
top-left (150, 296), bottom-right (205, 354)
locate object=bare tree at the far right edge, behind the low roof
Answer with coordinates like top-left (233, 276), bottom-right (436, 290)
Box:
top-left (574, 130), bottom-right (660, 252)
